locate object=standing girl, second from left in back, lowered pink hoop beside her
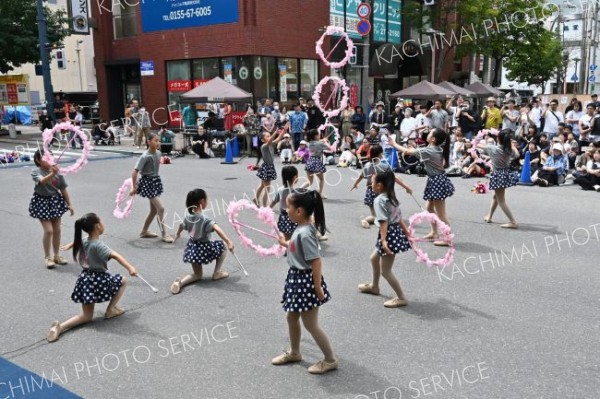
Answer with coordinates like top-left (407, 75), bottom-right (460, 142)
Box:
top-left (130, 133), bottom-right (173, 243)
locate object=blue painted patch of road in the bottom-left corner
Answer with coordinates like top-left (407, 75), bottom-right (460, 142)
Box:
top-left (0, 357), bottom-right (81, 399)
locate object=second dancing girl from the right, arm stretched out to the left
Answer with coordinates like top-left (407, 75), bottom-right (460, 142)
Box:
top-left (392, 128), bottom-right (454, 247)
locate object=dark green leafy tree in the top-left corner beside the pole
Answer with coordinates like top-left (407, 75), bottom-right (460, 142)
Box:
top-left (0, 0), bottom-right (69, 73)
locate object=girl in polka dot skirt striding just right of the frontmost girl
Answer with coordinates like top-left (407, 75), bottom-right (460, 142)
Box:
top-left (358, 170), bottom-right (410, 308)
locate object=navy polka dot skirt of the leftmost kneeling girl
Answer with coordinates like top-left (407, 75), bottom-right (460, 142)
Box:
top-left (71, 270), bottom-right (123, 304)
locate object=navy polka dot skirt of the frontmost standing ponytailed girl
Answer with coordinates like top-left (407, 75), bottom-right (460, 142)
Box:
top-left (281, 267), bottom-right (331, 312)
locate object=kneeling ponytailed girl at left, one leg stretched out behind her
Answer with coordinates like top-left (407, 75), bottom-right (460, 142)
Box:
top-left (47, 213), bottom-right (137, 342)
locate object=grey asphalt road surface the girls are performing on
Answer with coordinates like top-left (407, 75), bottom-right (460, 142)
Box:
top-left (0, 154), bottom-right (600, 399)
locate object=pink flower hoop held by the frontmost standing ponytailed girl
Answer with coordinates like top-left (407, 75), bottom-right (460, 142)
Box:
top-left (227, 199), bottom-right (285, 257)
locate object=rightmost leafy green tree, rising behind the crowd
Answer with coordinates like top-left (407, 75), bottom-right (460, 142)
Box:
top-left (504, 30), bottom-right (563, 89)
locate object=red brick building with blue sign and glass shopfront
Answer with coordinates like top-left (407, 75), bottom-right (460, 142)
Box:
top-left (92, 0), bottom-right (329, 121)
